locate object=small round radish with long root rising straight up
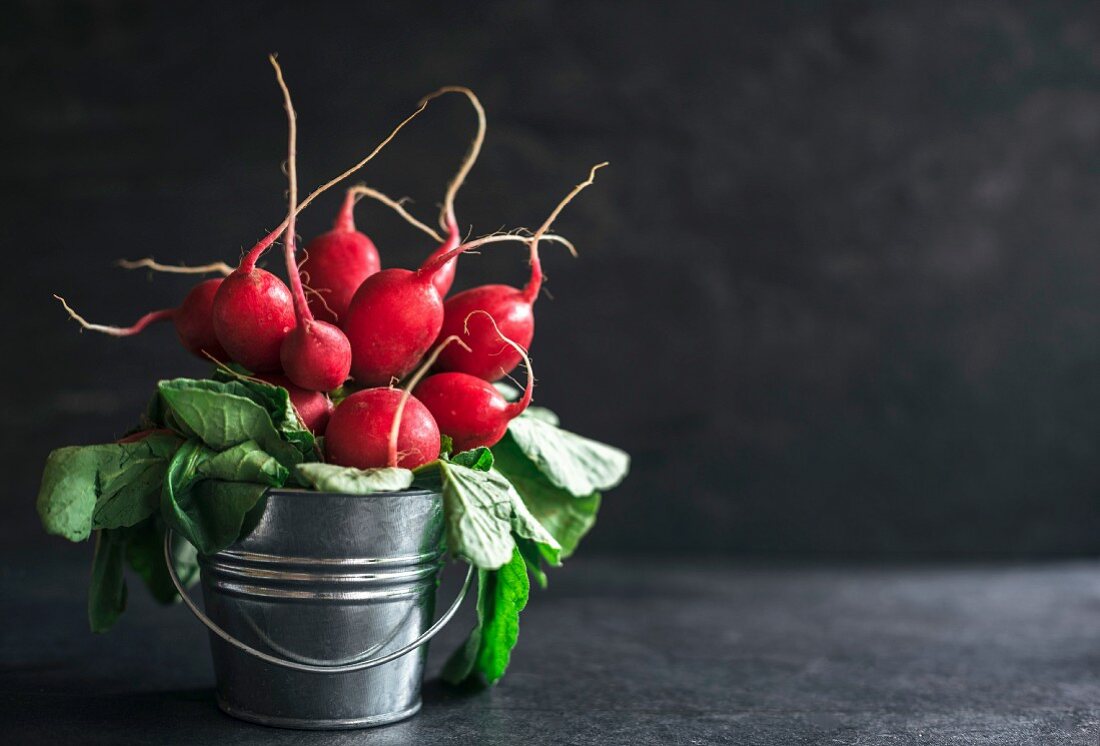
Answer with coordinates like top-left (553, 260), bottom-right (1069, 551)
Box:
top-left (267, 63), bottom-right (351, 391)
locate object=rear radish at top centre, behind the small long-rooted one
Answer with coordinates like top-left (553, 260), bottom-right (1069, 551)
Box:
top-left (300, 188), bottom-right (382, 323)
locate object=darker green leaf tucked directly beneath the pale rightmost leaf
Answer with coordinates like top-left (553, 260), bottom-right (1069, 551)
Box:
top-left (493, 439), bottom-right (601, 563)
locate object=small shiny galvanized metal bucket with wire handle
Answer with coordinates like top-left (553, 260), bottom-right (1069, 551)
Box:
top-left (165, 490), bottom-right (472, 728)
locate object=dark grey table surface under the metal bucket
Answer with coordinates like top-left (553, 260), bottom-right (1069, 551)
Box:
top-left (0, 547), bottom-right (1100, 746)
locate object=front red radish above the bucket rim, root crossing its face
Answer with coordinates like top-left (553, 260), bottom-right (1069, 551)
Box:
top-left (325, 337), bottom-right (462, 469)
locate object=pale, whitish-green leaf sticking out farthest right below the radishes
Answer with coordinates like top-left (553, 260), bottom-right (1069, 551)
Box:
top-left (505, 416), bottom-right (630, 497)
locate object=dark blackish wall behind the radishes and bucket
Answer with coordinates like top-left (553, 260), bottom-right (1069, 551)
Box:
top-left (0, 0), bottom-right (1100, 558)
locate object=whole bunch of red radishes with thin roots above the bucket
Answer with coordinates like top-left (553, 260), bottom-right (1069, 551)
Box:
top-left (62, 58), bottom-right (605, 469)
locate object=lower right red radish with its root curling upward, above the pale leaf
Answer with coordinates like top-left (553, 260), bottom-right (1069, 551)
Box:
top-left (413, 311), bottom-right (535, 452)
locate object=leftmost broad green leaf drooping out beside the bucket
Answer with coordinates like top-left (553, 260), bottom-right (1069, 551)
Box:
top-left (36, 435), bottom-right (179, 541)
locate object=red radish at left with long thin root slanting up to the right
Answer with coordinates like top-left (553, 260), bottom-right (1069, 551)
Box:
top-left (213, 55), bottom-right (427, 372)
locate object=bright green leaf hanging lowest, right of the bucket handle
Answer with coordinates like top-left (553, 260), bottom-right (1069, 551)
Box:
top-left (442, 549), bottom-right (530, 685)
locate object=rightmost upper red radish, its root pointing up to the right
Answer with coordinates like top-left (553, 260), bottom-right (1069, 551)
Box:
top-left (439, 163), bottom-right (607, 380)
